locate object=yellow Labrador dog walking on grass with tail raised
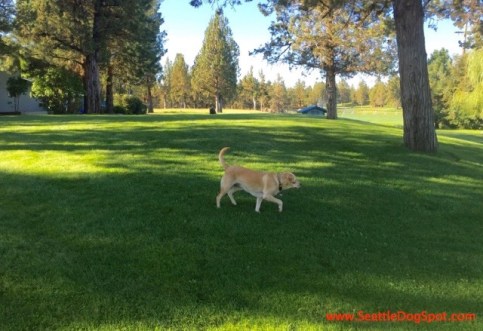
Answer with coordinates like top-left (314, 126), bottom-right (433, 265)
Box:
top-left (216, 147), bottom-right (300, 213)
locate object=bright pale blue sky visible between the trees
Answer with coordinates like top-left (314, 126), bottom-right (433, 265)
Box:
top-left (161, 0), bottom-right (461, 86)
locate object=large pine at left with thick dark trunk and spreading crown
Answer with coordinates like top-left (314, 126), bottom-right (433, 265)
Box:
top-left (17, 0), bottom-right (166, 113)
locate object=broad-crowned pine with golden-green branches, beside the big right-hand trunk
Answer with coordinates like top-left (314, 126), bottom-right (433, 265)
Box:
top-left (254, 1), bottom-right (394, 119)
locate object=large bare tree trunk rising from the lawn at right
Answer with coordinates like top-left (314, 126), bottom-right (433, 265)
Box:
top-left (393, 0), bottom-right (438, 152)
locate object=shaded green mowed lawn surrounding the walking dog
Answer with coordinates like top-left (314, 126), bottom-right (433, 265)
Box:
top-left (0, 111), bottom-right (483, 330)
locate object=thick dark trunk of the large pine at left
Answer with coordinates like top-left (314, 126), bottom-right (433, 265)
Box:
top-left (84, 54), bottom-right (101, 114)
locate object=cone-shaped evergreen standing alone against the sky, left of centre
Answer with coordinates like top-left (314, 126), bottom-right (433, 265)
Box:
top-left (192, 11), bottom-right (240, 112)
